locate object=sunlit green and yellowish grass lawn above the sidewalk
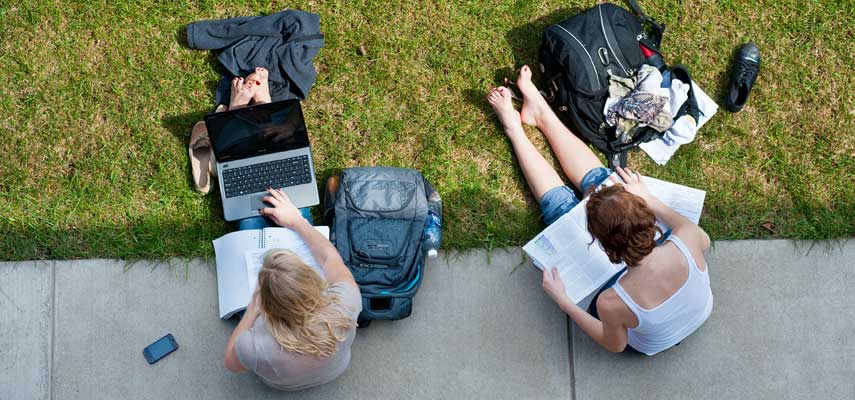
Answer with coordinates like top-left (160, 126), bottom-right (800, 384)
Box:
top-left (0, 0), bottom-right (855, 260)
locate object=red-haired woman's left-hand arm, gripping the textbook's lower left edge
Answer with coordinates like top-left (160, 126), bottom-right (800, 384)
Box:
top-left (543, 268), bottom-right (627, 353)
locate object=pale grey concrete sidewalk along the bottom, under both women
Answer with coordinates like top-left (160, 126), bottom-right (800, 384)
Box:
top-left (0, 241), bottom-right (855, 400)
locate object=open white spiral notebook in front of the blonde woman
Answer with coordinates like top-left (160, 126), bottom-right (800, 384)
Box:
top-left (214, 226), bottom-right (330, 319)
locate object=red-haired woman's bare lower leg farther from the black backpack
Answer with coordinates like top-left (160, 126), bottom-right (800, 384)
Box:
top-left (487, 87), bottom-right (564, 201)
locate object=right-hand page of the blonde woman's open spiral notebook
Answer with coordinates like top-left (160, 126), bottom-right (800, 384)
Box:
top-left (244, 226), bottom-right (330, 293)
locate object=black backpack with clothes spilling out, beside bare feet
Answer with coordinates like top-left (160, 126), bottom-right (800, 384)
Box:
top-left (539, 0), bottom-right (665, 167)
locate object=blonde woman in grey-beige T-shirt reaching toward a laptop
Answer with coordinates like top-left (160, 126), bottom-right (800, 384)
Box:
top-left (225, 189), bottom-right (362, 390)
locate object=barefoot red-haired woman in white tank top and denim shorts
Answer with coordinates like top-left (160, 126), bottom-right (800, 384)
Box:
top-left (487, 66), bottom-right (713, 355)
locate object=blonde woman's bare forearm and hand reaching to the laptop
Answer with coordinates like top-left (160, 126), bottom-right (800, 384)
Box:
top-left (260, 189), bottom-right (356, 286)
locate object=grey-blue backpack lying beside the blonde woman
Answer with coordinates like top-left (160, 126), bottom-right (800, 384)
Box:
top-left (326, 167), bottom-right (433, 326)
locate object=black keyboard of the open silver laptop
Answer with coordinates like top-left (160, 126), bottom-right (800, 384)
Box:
top-left (223, 155), bottom-right (312, 198)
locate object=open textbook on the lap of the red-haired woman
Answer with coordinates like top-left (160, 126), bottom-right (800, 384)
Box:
top-left (523, 174), bottom-right (706, 304)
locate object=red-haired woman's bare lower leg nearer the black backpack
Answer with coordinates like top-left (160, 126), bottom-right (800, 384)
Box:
top-left (517, 65), bottom-right (603, 191)
